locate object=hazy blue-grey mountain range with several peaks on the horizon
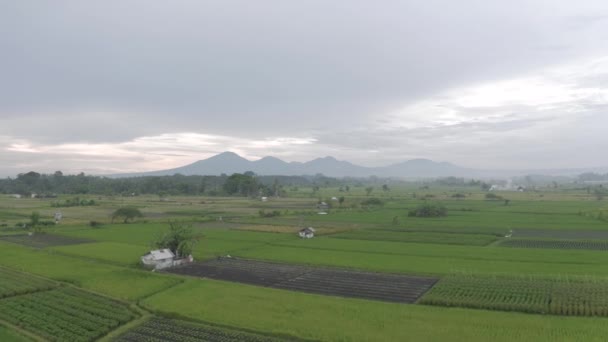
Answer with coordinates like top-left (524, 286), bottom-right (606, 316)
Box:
top-left (114, 152), bottom-right (475, 178)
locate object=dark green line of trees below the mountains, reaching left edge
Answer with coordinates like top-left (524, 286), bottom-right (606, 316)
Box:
top-left (0, 171), bottom-right (390, 197)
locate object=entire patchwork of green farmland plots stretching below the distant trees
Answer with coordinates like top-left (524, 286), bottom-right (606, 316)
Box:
top-left (0, 186), bottom-right (608, 341)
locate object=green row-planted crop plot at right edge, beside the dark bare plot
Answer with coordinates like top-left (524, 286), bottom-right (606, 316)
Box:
top-left (420, 274), bottom-right (608, 316)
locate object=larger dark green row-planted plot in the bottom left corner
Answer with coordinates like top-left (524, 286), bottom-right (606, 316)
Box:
top-left (0, 288), bottom-right (135, 341)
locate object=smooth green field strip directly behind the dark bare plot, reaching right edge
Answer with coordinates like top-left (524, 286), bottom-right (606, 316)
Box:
top-left (234, 238), bottom-right (608, 275)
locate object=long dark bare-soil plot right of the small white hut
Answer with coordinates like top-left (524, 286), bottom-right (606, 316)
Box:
top-left (169, 258), bottom-right (438, 303)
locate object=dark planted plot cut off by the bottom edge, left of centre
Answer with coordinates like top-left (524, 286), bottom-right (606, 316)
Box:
top-left (116, 318), bottom-right (282, 342)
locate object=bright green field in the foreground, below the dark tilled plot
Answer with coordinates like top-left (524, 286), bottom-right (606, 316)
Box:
top-left (144, 280), bottom-right (608, 341)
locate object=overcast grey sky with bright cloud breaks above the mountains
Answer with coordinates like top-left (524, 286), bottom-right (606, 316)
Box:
top-left (0, 0), bottom-right (608, 176)
